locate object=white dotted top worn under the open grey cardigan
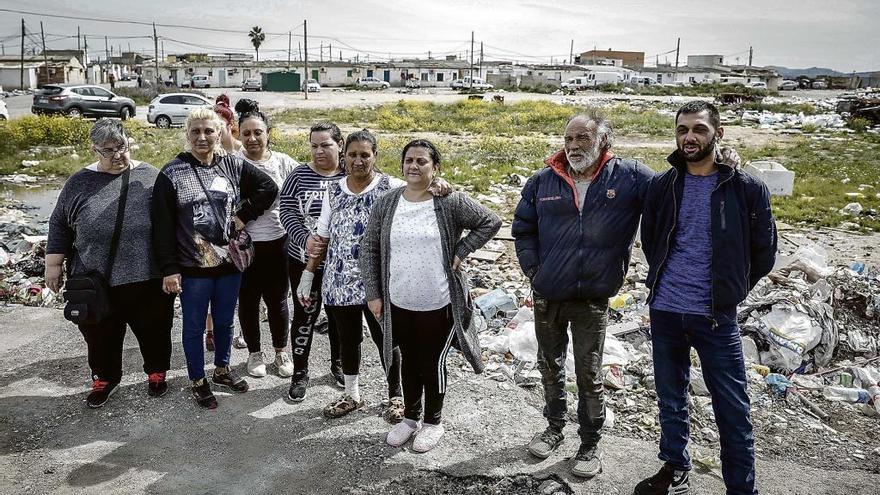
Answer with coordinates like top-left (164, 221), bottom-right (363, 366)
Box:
top-left (388, 196), bottom-right (450, 311)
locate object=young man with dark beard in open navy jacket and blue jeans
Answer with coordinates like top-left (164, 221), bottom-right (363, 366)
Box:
top-left (635, 101), bottom-right (776, 495)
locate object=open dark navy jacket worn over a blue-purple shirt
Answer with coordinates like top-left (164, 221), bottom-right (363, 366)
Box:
top-left (642, 151), bottom-right (776, 314)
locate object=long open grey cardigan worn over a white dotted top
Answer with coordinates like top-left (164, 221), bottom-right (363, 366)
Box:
top-left (360, 187), bottom-right (501, 373)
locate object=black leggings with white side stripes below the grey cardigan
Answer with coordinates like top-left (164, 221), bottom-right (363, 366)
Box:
top-left (391, 304), bottom-right (452, 425)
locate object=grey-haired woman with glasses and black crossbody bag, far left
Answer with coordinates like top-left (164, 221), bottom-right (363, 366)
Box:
top-left (45, 119), bottom-right (174, 408)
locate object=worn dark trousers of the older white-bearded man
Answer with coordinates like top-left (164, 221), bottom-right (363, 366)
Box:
top-left (534, 294), bottom-right (608, 445)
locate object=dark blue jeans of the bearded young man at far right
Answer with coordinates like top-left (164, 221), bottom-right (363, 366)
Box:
top-left (651, 308), bottom-right (757, 495)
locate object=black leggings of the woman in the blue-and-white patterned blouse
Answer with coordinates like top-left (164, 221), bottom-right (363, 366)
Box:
top-left (327, 304), bottom-right (401, 397)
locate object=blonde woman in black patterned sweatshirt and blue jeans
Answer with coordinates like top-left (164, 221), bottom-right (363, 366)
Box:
top-left (152, 108), bottom-right (278, 409)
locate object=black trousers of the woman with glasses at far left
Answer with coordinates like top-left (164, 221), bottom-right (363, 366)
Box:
top-left (79, 279), bottom-right (174, 382)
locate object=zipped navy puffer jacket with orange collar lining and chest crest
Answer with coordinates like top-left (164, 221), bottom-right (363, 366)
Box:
top-left (511, 152), bottom-right (654, 301)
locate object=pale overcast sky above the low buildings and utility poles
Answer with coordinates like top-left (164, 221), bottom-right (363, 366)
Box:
top-left (0, 0), bottom-right (880, 72)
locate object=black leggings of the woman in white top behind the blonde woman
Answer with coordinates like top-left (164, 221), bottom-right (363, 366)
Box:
top-left (238, 236), bottom-right (290, 352)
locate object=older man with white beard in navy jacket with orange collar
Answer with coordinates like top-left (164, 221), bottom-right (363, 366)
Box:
top-left (512, 114), bottom-right (654, 478)
